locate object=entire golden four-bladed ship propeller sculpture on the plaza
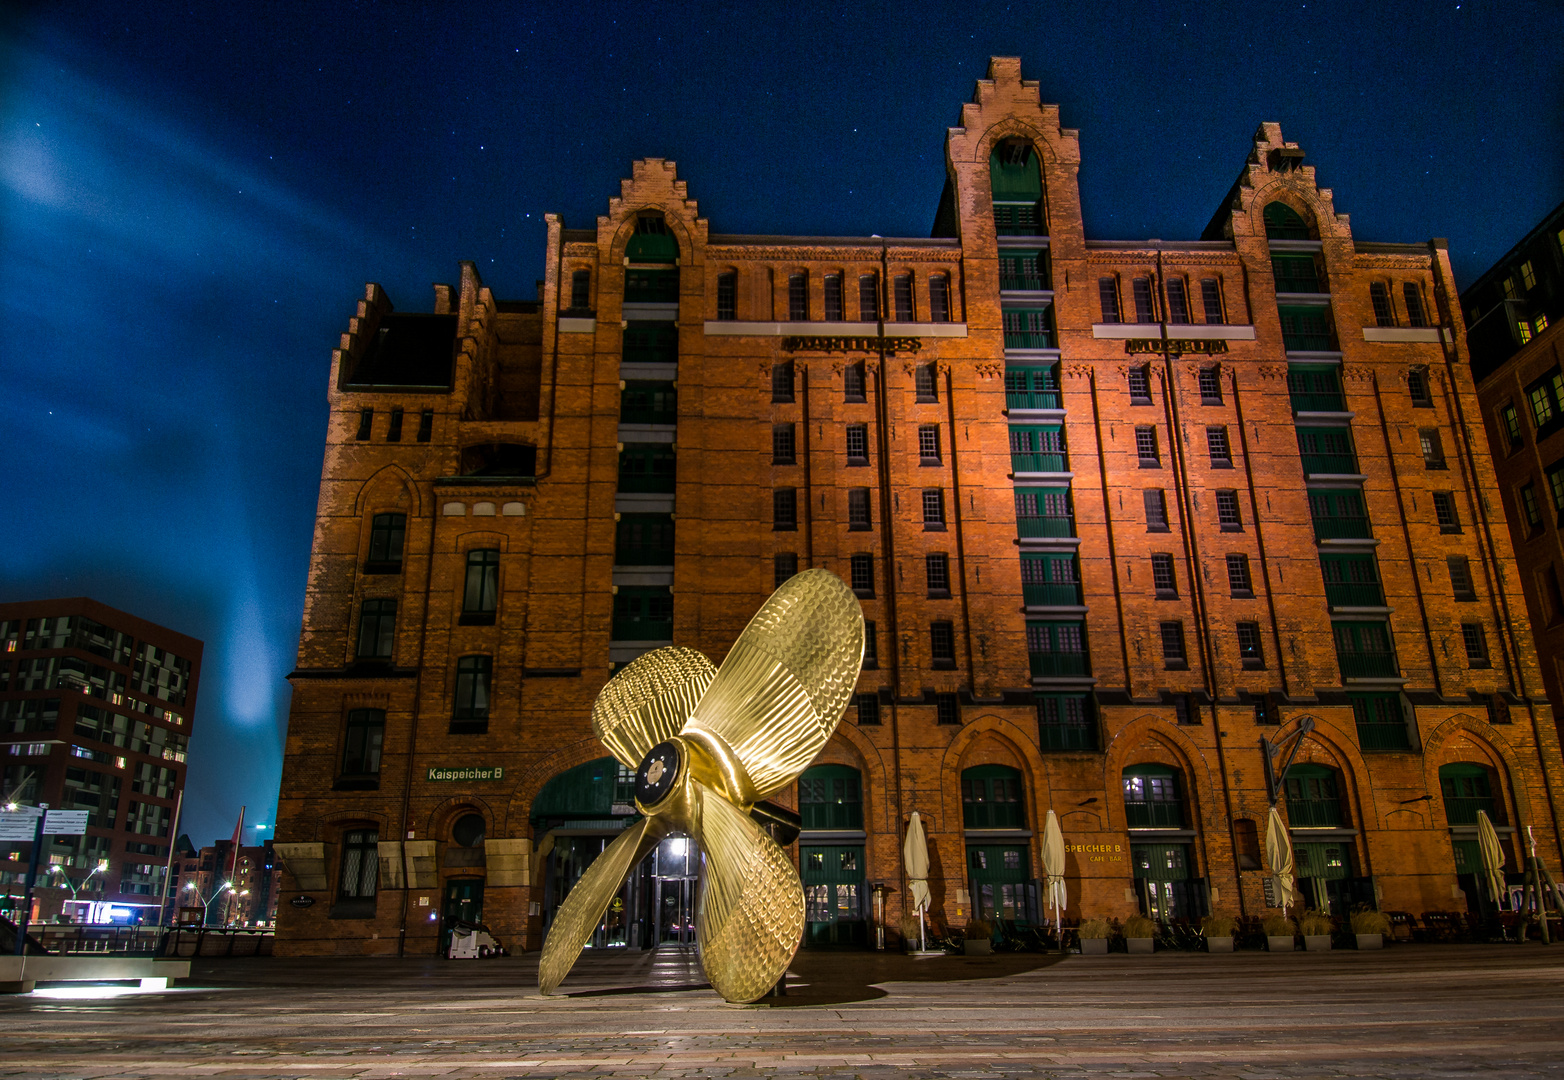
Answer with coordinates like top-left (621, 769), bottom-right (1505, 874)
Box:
top-left (538, 569), bottom-right (863, 1002)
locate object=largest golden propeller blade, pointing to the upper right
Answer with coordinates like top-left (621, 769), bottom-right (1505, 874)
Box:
top-left (681, 569), bottom-right (863, 803)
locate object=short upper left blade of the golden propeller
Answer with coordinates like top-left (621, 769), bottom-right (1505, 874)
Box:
top-left (591, 645), bottom-right (716, 769)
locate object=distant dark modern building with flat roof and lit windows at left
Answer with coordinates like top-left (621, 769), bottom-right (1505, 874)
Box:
top-left (0, 597), bottom-right (202, 922)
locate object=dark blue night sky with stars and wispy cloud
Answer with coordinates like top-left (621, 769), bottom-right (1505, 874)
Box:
top-left (0, 0), bottom-right (1564, 844)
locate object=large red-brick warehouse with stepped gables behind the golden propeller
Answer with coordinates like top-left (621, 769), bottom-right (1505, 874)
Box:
top-left (277, 58), bottom-right (1564, 953)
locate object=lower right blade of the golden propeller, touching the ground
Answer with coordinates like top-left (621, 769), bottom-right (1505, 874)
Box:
top-left (690, 785), bottom-right (804, 1002)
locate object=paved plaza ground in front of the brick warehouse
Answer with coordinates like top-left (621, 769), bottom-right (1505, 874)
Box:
top-left (0, 946), bottom-right (1564, 1080)
